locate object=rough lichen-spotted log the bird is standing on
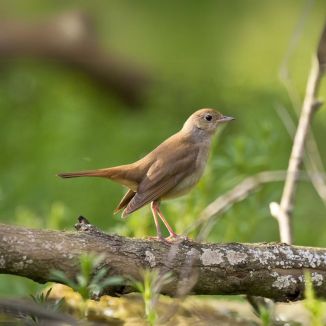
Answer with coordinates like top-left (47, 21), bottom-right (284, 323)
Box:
top-left (0, 218), bottom-right (326, 301)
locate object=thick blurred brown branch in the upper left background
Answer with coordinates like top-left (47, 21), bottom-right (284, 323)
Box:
top-left (0, 11), bottom-right (151, 104)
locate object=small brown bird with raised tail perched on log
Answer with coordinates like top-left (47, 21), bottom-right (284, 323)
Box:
top-left (58, 108), bottom-right (234, 239)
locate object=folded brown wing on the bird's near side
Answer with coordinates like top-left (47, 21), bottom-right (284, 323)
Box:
top-left (123, 148), bottom-right (198, 216)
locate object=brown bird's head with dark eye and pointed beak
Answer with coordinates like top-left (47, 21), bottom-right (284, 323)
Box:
top-left (182, 108), bottom-right (234, 135)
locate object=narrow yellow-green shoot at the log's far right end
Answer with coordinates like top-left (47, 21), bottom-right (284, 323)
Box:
top-left (304, 272), bottom-right (325, 326)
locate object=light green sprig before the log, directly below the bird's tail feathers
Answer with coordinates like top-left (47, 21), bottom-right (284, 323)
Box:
top-left (130, 269), bottom-right (171, 326)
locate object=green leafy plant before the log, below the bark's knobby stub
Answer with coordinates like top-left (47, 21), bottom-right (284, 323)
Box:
top-left (52, 254), bottom-right (122, 300)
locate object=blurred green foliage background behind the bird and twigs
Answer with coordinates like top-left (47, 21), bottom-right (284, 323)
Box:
top-left (0, 0), bottom-right (326, 295)
